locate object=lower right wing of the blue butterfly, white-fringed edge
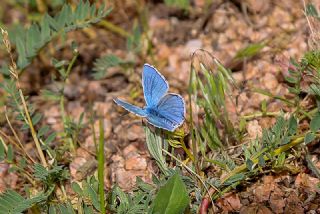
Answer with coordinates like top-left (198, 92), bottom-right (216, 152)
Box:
top-left (147, 94), bottom-right (185, 131)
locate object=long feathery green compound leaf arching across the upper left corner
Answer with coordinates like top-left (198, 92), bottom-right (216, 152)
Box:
top-left (6, 1), bottom-right (110, 70)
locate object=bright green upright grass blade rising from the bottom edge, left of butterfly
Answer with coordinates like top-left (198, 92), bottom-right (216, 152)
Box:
top-left (98, 118), bottom-right (106, 213)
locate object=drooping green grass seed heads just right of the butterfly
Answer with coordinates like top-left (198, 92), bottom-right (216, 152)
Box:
top-left (189, 52), bottom-right (239, 151)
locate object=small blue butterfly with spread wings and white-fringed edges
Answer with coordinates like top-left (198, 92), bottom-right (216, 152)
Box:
top-left (114, 64), bottom-right (185, 132)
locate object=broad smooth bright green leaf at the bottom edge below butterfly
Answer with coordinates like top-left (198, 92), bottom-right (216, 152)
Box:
top-left (153, 173), bottom-right (190, 214)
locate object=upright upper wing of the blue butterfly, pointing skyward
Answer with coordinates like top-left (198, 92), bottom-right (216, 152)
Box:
top-left (142, 64), bottom-right (169, 107)
